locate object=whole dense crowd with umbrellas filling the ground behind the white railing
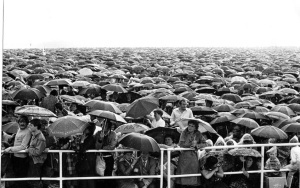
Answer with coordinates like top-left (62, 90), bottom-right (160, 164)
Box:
top-left (1, 47), bottom-right (300, 188)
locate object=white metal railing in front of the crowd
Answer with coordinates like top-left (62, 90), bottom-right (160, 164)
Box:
top-left (1, 143), bottom-right (300, 188)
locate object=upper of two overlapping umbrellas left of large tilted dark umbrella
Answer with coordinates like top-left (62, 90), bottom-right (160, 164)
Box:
top-left (84, 100), bottom-right (122, 114)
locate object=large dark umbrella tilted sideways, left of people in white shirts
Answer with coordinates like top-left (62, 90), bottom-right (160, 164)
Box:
top-left (126, 97), bottom-right (159, 118)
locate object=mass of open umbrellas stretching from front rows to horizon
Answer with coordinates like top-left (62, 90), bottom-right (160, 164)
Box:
top-left (2, 48), bottom-right (300, 187)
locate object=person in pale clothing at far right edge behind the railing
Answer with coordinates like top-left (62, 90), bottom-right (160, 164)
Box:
top-left (284, 136), bottom-right (300, 188)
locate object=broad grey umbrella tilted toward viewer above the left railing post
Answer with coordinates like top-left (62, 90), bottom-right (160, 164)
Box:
top-left (48, 116), bottom-right (89, 138)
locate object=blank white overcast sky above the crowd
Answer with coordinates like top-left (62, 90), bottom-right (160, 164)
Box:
top-left (4, 0), bottom-right (300, 49)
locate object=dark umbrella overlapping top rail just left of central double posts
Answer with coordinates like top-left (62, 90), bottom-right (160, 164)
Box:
top-left (119, 133), bottom-right (160, 153)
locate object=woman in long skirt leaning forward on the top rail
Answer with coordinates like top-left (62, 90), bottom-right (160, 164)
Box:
top-left (176, 120), bottom-right (206, 187)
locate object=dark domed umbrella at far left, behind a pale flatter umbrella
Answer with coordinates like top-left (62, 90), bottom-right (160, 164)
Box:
top-left (12, 88), bottom-right (44, 100)
